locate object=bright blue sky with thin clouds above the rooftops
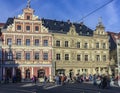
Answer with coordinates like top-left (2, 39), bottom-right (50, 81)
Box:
top-left (0, 0), bottom-right (120, 33)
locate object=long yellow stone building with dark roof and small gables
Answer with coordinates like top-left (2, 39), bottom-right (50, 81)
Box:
top-left (43, 20), bottom-right (113, 75)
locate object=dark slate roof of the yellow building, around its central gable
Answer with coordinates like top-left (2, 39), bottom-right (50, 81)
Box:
top-left (42, 19), bottom-right (93, 36)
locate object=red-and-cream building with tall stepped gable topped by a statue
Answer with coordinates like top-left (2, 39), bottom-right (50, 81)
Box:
top-left (2, 5), bottom-right (52, 80)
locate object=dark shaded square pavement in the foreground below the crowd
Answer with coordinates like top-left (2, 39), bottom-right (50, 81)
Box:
top-left (0, 83), bottom-right (120, 93)
